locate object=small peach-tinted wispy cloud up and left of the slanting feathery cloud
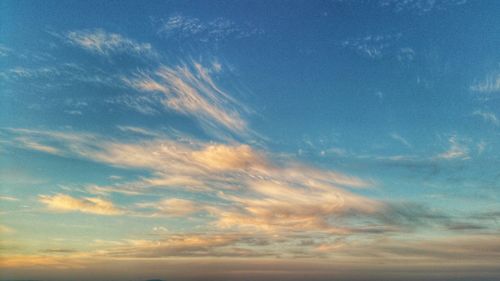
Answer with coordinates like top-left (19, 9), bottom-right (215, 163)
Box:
top-left (59, 29), bottom-right (158, 58)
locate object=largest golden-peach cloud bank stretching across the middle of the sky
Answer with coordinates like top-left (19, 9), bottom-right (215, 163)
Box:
top-left (4, 127), bottom-right (385, 233)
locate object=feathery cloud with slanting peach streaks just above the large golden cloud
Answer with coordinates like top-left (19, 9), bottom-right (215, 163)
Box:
top-left (124, 61), bottom-right (248, 134)
